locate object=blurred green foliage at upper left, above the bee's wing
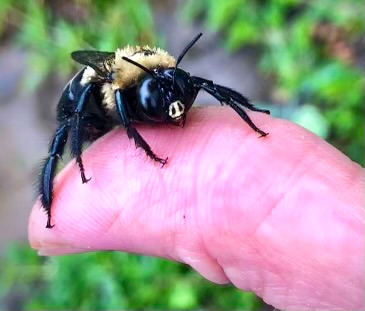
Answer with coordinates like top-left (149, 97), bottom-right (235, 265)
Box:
top-left (0, 0), bottom-right (155, 89)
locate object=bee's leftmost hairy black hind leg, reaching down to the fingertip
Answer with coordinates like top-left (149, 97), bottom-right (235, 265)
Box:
top-left (39, 122), bottom-right (70, 228)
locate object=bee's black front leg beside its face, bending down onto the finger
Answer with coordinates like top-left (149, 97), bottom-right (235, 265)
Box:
top-left (115, 90), bottom-right (168, 167)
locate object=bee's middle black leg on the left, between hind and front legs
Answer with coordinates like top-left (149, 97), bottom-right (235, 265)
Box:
top-left (71, 83), bottom-right (94, 184)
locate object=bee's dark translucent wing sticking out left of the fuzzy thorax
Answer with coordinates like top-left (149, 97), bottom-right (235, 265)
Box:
top-left (71, 51), bottom-right (115, 77)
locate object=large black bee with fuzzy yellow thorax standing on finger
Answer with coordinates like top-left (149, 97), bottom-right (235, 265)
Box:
top-left (39, 33), bottom-right (270, 228)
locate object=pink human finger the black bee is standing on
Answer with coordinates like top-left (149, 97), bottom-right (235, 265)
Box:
top-left (29, 107), bottom-right (364, 310)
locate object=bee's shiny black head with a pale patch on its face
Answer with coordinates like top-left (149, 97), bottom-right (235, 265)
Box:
top-left (138, 68), bottom-right (196, 123)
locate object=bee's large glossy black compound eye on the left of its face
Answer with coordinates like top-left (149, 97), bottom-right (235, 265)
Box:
top-left (137, 78), bottom-right (167, 122)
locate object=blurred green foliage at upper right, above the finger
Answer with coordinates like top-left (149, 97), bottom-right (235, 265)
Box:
top-left (184, 0), bottom-right (364, 164)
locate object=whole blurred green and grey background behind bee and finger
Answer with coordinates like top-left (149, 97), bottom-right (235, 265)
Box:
top-left (0, 0), bottom-right (365, 310)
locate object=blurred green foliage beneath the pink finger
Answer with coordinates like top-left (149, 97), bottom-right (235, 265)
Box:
top-left (0, 246), bottom-right (262, 310)
